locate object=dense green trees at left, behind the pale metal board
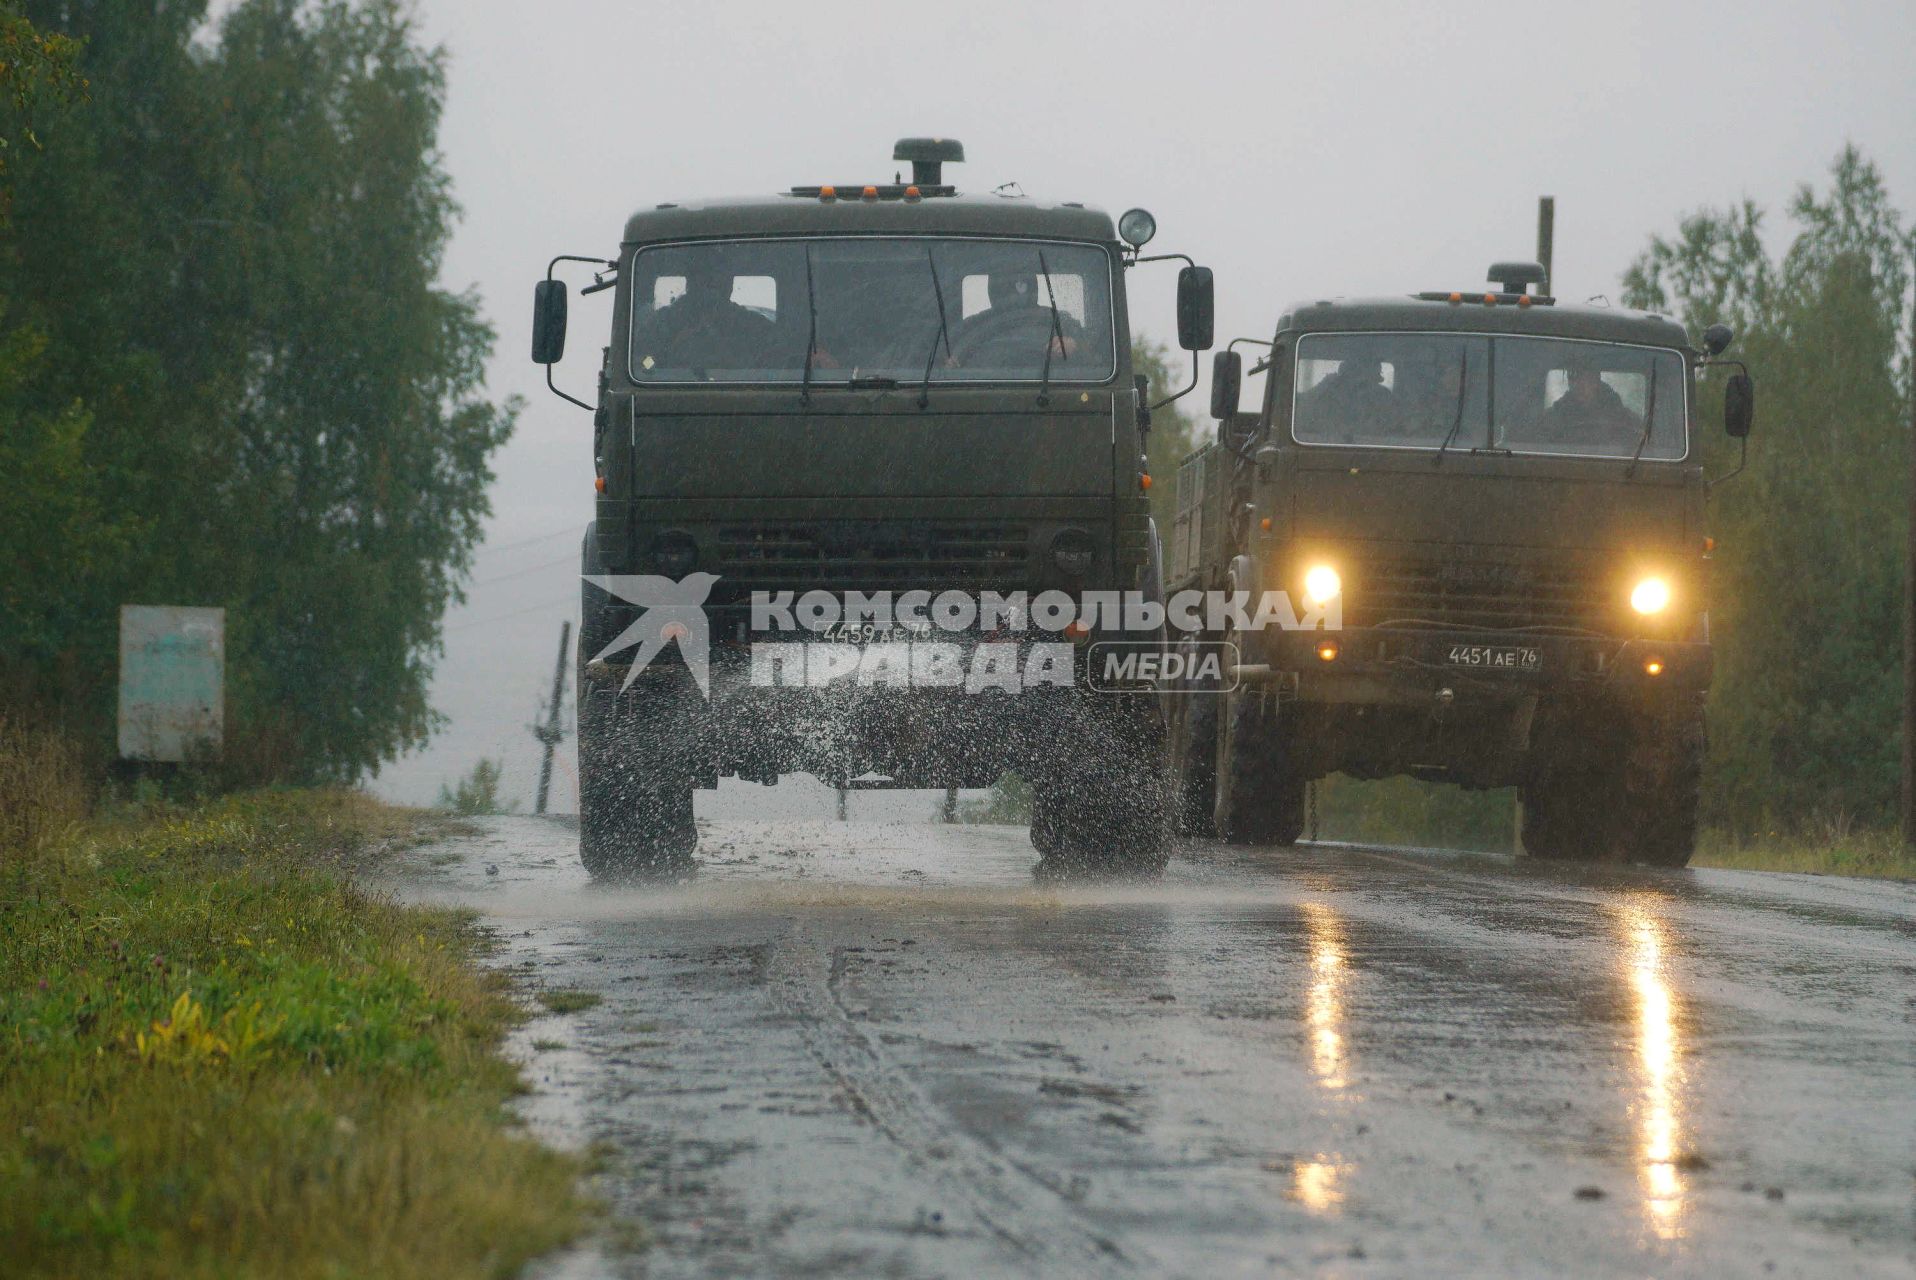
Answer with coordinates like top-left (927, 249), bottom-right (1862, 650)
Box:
top-left (0, 0), bottom-right (515, 778)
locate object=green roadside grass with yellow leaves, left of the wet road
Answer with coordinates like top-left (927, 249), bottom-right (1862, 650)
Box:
top-left (0, 791), bottom-right (592, 1278)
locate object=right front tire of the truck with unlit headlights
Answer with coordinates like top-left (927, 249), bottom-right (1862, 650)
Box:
top-left (1031, 697), bottom-right (1171, 880)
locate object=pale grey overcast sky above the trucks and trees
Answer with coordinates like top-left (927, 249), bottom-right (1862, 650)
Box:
top-left (365, 0), bottom-right (1916, 809)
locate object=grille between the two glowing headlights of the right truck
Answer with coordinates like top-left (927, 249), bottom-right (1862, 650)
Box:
top-left (1343, 558), bottom-right (1617, 632)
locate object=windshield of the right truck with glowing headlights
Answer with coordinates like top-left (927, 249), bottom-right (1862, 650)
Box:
top-left (1291, 333), bottom-right (1688, 462)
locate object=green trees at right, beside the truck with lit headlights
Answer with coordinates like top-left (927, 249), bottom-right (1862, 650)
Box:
top-left (1625, 148), bottom-right (1916, 832)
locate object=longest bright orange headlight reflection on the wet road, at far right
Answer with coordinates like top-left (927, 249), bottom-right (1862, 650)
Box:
top-left (1621, 904), bottom-right (1684, 1240)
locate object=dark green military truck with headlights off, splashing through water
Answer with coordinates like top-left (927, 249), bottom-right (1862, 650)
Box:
top-left (533, 138), bottom-right (1213, 876)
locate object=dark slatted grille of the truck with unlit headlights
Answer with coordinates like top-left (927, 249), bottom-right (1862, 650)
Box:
top-left (713, 519), bottom-right (1031, 592)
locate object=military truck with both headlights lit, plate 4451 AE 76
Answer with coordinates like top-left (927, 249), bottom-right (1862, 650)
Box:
top-left (1167, 263), bottom-right (1753, 866)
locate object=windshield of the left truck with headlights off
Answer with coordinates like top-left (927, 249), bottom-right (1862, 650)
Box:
top-left (628, 236), bottom-right (1117, 387)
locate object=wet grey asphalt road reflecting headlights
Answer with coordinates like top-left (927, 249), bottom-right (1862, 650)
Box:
top-left (385, 818), bottom-right (1916, 1276)
